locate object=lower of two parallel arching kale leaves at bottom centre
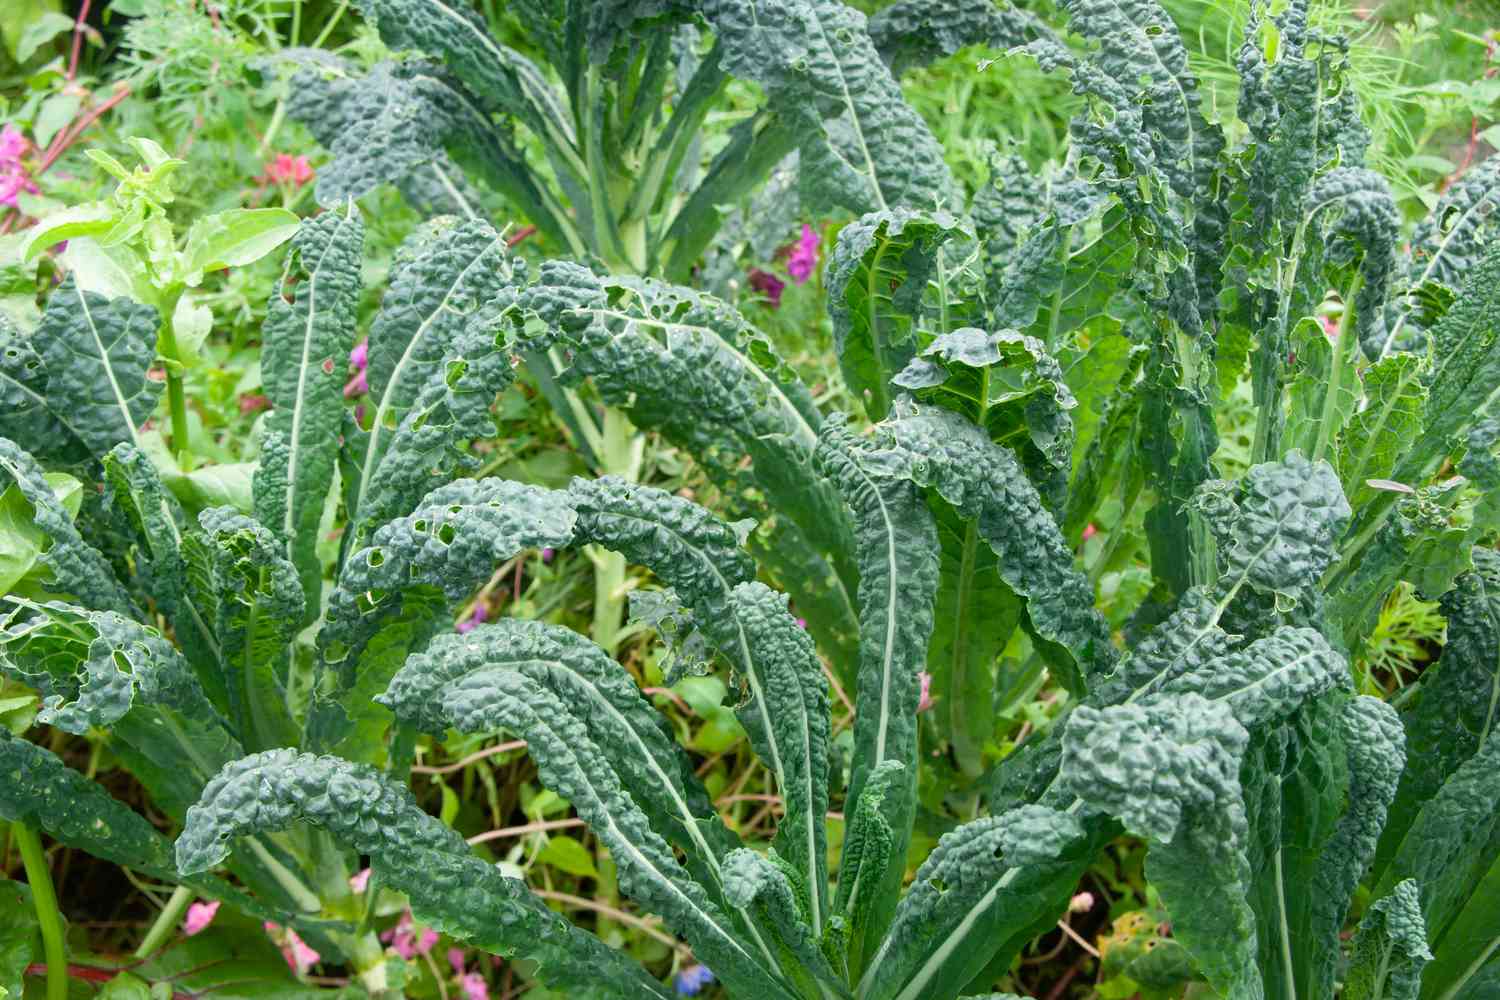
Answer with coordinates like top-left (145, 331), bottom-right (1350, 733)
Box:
top-left (443, 665), bottom-right (792, 997)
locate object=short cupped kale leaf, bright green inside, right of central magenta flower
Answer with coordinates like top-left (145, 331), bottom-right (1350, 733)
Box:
top-left (828, 210), bottom-right (962, 420)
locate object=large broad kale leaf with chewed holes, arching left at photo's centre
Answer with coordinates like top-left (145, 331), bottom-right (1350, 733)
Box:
top-left (522, 261), bottom-right (858, 684)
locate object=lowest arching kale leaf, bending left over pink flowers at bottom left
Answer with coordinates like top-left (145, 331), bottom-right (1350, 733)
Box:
top-left (177, 750), bottom-right (672, 1000)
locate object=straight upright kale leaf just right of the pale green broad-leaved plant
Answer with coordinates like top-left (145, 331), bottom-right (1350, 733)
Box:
top-left (255, 204), bottom-right (365, 618)
